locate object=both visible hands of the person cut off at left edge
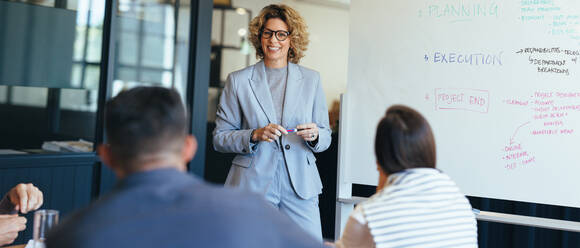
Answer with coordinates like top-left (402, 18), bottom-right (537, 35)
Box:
top-left (0, 183), bottom-right (43, 246)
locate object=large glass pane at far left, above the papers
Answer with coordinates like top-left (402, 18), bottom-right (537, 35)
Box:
top-left (0, 0), bottom-right (105, 153)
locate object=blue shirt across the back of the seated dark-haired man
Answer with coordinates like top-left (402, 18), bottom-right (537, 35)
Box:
top-left (48, 182), bottom-right (324, 247)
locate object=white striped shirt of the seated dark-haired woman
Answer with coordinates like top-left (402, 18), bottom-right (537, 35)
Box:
top-left (340, 168), bottom-right (477, 247)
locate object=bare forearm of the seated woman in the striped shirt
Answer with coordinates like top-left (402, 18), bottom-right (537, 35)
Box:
top-left (335, 207), bottom-right (375, 248)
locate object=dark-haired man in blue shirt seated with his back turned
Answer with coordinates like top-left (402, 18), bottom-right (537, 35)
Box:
top-left (46, 87), bottom-right (322, 248)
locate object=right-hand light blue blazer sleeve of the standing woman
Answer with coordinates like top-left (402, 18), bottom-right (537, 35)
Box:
top-left (307, 73), bottom-right (332, 152)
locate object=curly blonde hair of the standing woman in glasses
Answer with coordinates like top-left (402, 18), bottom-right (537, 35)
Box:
top-left (249, 4), bottom-right (309, 64)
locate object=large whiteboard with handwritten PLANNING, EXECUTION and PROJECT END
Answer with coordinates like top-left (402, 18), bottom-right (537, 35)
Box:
top-left (339, 0), bottom-right (580, 207)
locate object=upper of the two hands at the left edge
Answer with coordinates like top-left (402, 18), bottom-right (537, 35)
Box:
top-left (8, 183), bottom-right (44, 214)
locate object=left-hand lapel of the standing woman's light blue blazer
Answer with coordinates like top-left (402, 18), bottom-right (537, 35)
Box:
top-left (250, 61), bottom-right (276, 123)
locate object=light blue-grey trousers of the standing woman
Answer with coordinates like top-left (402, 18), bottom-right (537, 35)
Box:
top-left (266, 152), bottom-right (322, 242)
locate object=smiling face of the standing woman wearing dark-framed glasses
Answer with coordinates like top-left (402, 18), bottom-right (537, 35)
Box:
top-left (261, 18), bottom-right (290, 64)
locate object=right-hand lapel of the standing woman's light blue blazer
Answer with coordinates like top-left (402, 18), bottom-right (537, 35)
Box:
top-left (282, 62), bottom-right (303, 128)
